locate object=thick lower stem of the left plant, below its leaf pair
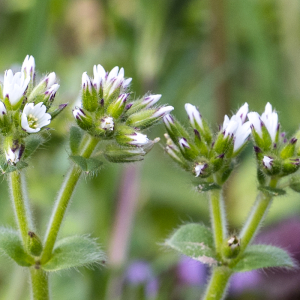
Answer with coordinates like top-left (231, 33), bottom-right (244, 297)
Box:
top-left (30, 267), bottom-right (50, 300)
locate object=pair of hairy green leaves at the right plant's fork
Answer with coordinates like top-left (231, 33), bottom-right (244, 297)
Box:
top-left (165, 223), bottom-right (296, 272)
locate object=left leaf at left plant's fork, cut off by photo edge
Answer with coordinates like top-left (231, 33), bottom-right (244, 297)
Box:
top-left (0, 227), bottom-right (35, 267)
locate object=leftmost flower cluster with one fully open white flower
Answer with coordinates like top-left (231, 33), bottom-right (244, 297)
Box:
top-left (0, 55), bottom-right (66, 165)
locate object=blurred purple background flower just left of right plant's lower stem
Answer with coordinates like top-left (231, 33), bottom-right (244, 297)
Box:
top-left (177, 256), bottom-right (206, 285)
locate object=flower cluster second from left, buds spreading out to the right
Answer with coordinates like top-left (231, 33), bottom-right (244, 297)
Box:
top-left (73, 65), bottom-right (173, 162)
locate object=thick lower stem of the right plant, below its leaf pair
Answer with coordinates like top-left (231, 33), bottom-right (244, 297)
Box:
top-left (203, 267), bottom-right (232, 300)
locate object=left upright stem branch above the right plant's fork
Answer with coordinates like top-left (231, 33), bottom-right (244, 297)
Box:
top-left (210, 189), bottom-right (227, 255)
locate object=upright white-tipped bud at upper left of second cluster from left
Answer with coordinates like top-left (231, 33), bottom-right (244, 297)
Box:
top-left (82, 72), bottom-right (98, 112)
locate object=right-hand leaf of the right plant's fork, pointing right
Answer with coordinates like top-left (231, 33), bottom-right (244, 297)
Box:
top-left (233, 245), bottom-right (296, 272)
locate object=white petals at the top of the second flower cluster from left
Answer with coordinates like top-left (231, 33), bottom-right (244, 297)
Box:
top-left (92, 65), bottom-right (132, 96)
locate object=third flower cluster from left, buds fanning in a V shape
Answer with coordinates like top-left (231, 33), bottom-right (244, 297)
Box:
top-left (164, 103), bottom-right (251, 183)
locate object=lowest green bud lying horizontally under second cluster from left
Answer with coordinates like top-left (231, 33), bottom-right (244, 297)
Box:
top-left (104, 144), bottom-right (146, 163)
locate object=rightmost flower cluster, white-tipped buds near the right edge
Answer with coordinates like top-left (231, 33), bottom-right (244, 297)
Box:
top-left (248, 103), bottom-right (300, 180)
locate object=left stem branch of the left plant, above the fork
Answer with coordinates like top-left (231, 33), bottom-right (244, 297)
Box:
top-left (9, 171), bottom-right (32, 249)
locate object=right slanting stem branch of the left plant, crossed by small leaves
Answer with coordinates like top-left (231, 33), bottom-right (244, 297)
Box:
top-left (41, 137), bottom-right (99, 264)
